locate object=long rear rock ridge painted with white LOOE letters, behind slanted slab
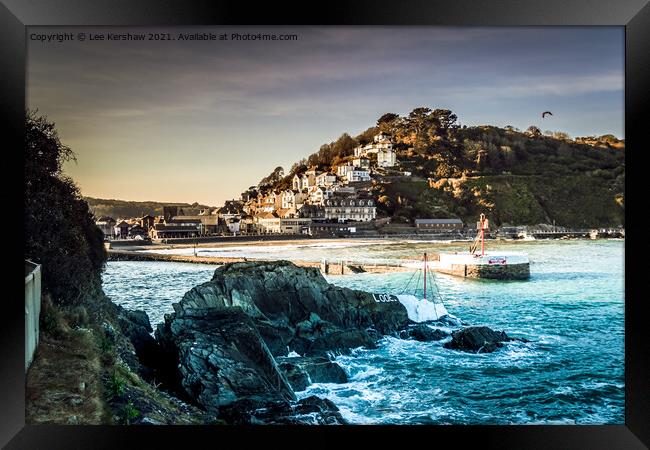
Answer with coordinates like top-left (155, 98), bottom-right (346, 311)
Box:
top-left (174, 261), bottom-right (410, 356)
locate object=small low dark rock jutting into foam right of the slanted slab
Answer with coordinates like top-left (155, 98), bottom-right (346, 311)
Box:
top-left (278, 356), bottom-right (348, 391)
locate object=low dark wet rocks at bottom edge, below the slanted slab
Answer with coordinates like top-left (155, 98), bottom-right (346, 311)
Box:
top-left (220, 396), bottom-right (346, 425)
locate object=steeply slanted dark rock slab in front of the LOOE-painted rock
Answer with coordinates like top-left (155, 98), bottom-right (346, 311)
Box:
top-left (156, 307), bottom-right (295, 412)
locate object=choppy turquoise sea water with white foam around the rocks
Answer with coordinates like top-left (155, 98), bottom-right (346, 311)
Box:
top-left (104, 240), bottom-right (624, 424)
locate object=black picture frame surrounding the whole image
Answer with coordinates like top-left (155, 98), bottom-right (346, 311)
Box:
top-left (0, 0), bottom-right (650, 449)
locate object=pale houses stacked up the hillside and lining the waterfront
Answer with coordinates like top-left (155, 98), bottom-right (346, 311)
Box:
top-left (96, 133), bottom-right (462, 240)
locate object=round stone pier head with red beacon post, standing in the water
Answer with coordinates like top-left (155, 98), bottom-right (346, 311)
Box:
top-left (405, 214), bottom-right (530, 280)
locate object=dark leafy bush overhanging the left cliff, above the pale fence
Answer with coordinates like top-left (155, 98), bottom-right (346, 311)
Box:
top-left (24, 111), bottom-right (106, 305)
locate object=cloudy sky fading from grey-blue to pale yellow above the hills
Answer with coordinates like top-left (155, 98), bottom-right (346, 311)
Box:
top-left (27, 26), bottom-right (624, 206)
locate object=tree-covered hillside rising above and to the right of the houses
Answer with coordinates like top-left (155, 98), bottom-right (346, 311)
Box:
top-left (257, 108), bottom-right (625, 227)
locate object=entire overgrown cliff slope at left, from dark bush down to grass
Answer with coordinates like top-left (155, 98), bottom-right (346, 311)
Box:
top-left (24, 111), bottom-right (208, 424)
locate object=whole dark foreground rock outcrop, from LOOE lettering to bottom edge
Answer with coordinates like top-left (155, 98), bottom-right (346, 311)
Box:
top-left (156, 261), bottom-right (412, 424)
